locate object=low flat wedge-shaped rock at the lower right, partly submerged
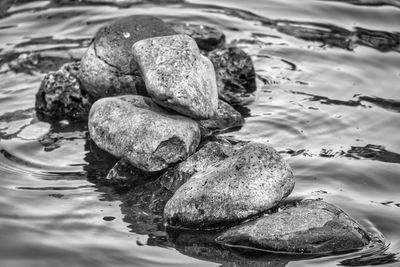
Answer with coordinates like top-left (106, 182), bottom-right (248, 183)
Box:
top-left (216, 200), bottom-right (370, 254)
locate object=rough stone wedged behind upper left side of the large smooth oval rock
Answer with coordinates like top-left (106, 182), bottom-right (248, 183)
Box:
top-left (160, 142), bottom-right (234, 193)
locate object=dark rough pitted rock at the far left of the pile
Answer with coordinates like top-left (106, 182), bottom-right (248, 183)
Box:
top-left (35, 62), bottom-right (91, 120)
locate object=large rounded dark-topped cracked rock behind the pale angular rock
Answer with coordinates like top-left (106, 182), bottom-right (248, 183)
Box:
top-left (79, 15), bottom-right (175, 99)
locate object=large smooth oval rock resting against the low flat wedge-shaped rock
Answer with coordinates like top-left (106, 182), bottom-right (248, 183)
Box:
top-left (164, 143), bottom-right (294, 228)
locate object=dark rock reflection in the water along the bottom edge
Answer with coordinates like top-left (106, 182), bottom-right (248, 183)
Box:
top-left (167, 228), bottom-right (295, 267)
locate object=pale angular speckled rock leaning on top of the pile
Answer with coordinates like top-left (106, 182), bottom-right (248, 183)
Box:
top-left (133, 35), bottom-right (218, 119)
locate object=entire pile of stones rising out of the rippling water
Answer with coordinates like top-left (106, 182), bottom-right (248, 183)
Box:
top-left (37, 16), bottom-right (371, 254)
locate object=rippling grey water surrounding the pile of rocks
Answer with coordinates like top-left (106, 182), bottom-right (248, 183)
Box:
top-left (0, 0), bottom-right (400, 267)
